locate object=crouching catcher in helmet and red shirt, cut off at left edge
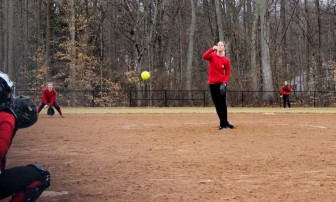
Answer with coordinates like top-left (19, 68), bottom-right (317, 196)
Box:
top-left (0, 72), bottom-right (50, 202)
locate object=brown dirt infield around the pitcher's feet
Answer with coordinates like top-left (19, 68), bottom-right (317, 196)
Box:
top-left (4, 109), bottom-right (336, 202)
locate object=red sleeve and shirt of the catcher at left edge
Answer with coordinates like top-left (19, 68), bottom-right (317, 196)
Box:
top-left (0, 111), bottom-right (15, 170)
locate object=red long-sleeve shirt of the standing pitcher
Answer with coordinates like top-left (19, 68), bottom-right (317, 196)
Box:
top-left (202, 48), bottom-right (231, 84)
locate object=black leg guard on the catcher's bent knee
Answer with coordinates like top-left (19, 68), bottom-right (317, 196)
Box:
top-left (24, 164), bottom-right (50, 202)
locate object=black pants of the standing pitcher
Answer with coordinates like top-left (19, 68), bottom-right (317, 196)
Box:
top-left (209, 83), bottom-right (228, 127)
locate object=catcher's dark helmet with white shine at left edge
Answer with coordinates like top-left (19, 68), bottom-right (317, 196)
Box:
top-left (0, 71), bottom-right (14, 109)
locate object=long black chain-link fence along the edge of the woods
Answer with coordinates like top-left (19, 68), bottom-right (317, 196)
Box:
top-left (16, 90), bottom-right (336, 107)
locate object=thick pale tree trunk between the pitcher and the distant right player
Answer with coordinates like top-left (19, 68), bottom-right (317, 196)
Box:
top-left (258, 0), bottom-right (274, 101)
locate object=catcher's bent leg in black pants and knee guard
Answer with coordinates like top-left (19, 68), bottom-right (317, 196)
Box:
top-left (0, 166), bottom-right (50, 199)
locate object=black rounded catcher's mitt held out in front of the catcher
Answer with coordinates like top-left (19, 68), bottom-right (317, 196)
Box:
top-left (12, 95), bottom-right (38, 128)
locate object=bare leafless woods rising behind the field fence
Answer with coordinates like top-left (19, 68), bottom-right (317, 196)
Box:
top-left (0, 0), bottom-right (336, 104)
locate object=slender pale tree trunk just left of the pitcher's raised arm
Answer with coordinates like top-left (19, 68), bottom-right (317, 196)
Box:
top-left (186, 0), bottom-right (196, 93)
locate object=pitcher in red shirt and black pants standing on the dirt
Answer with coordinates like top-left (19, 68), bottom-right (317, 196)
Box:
top-left (202, 41), bottom-right (234, 130)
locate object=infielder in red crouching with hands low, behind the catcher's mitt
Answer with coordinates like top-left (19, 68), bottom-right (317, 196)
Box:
top-left (37, 82), bottom-right (64, 118)
